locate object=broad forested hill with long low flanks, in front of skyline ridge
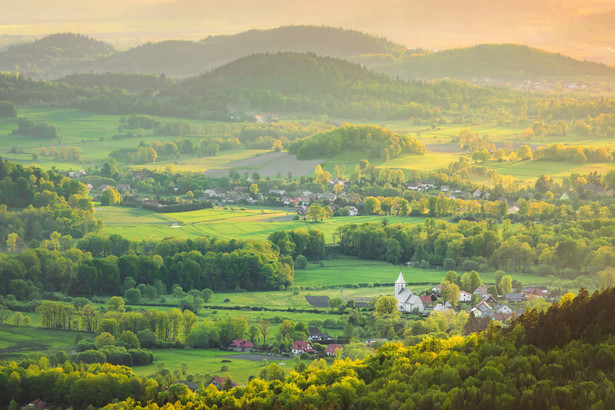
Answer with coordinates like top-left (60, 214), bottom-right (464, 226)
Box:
top-left (0, 53), bottom-right (532, 121)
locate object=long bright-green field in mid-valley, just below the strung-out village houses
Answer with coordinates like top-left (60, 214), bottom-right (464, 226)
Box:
top-left (96, 206), bottom-right (425, 243)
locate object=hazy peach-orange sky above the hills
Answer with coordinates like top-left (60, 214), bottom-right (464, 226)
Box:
top-left (0, 0), bottom-right (615, 65)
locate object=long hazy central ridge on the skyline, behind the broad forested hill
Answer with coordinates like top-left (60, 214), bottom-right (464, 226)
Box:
top-left (94, 26), bottom-right (406, 77)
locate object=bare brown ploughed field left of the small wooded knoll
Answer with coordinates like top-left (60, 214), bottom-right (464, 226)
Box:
top-left (205, 152), bottom-right (322, 178)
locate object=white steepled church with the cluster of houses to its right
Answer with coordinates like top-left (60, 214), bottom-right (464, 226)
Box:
top-left (395, 272), bottom-right (548, 321)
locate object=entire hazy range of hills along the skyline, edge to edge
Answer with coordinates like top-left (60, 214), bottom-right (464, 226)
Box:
top-left (0, 26), bottom-right (615, 80)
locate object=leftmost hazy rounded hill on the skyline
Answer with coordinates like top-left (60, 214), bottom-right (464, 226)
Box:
top-left (0, 33), bottom-right (115, 77)
